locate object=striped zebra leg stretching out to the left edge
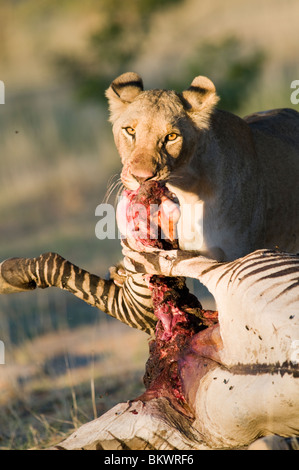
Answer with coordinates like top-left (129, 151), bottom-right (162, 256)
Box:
top-left (0, 253), bottom-right (157, 335)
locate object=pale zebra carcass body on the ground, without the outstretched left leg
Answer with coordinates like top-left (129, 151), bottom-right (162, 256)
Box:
top-left (50, 248), bottom-right (299, 450)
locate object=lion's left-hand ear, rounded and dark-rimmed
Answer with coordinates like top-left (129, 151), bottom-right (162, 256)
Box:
top-left (106, 72), bottom-right (143, 122)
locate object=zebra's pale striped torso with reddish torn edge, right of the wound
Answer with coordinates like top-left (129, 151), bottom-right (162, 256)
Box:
top-left (124, 246), bottom-right (299, 449)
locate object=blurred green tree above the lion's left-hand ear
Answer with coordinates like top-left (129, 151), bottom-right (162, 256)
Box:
top-left (55, 0), bottom-right (184, 100)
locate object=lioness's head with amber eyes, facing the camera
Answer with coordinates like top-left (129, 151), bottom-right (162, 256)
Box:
top-left (106, 72), bottom-right (218, 190)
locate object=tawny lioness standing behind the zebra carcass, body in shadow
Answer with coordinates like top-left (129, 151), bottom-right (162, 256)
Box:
top-left (106, 72), bottom-right (299, 261)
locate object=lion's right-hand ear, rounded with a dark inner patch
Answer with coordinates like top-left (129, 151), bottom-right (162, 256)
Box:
top-left (182, 76), bottom-right (219, 123)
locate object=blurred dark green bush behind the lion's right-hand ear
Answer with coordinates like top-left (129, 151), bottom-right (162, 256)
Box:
top-left (167, 36), bottom-right (266, 113)
